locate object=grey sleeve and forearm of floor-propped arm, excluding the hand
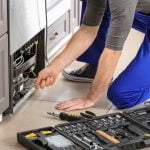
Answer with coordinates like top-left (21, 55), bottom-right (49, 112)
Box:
top-left (88, 0), bottom-right (138, 100)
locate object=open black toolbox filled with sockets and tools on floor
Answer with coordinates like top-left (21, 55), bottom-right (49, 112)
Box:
top-left (17, 108), bottom-right (150, 150)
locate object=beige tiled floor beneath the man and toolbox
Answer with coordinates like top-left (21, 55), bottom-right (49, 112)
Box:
top-left (0, 30), bottom-right (149, 150)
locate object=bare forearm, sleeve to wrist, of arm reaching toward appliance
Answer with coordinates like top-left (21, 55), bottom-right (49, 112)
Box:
top-left (50, 25), bottom-right (98, 71)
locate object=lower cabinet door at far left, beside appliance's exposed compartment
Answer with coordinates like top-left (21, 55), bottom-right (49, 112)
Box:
top-left (0, 34), bottom-right (9, 114)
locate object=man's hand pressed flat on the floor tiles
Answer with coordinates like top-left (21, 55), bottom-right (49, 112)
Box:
top-left (56, 96), bottom-right (97, 111)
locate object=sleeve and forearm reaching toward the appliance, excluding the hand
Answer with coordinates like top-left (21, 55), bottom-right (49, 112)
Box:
top-left (51, 0), bottom-right (107, 71)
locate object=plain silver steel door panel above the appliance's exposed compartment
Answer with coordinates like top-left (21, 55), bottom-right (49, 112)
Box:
top-left (9, 0), bottom-right (46, 55)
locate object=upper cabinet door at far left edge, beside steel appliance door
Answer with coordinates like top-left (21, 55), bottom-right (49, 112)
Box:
top-left (0, 0), bottom-right (7, 36)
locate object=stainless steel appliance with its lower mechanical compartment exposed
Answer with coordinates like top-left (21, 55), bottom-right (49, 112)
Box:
top-left (6, 0), bottom-right (46, 113)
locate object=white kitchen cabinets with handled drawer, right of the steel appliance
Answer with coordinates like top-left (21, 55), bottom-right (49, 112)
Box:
top-left (47, 0), bottom-right (80, 57)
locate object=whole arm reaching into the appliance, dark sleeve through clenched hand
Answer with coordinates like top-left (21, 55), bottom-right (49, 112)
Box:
top-left (35, 0), bottom-right (107, 89)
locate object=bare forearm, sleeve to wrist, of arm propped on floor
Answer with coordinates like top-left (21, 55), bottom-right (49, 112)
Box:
top-left (88, 48), bottom-right (121, 100)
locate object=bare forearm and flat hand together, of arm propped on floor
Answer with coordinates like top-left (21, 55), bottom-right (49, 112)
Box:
top-left (56, 48), bottom-right (121, 111)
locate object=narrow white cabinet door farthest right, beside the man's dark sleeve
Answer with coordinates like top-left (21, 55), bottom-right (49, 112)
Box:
top-left (70, 0), bottom-right (80, 31)
